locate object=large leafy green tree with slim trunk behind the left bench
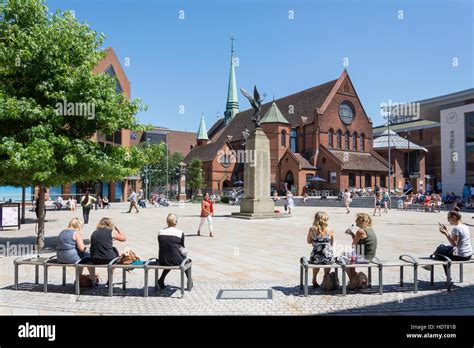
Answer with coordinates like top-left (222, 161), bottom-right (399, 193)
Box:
top-left (0, 0), bottom-right (159, 250)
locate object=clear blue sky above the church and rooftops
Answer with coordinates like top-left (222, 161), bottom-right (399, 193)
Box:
top-left (46, 0), bottom-right (474, 131)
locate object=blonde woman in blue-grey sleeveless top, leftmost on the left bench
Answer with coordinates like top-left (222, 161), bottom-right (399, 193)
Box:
top-left (56, 218), bottom-right (94, 276)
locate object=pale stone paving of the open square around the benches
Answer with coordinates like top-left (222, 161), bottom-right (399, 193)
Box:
top-left (0, 203), bottom-right (474, 315)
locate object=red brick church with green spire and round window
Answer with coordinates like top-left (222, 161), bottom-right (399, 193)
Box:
top-left (185, 46), bottom-right (388, 195)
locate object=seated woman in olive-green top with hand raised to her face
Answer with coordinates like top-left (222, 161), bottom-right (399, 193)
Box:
top-left (346, 213), bottom-right (377, 286)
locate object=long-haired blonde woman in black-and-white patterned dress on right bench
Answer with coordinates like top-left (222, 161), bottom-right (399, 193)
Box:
top-left (306, 211), bottom-right (334, 288)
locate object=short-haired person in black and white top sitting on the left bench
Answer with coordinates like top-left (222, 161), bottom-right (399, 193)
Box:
top-left (158, 214), bottom-right (191, 289)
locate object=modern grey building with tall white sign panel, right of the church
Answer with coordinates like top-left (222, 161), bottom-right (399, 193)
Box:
top-left (373, 88), bottom-right (474, 195)
